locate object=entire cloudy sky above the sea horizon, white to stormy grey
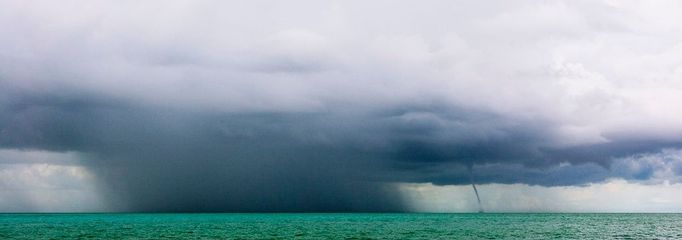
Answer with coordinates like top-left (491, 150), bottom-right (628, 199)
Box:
top-left (0, 0), bottom-right (682, 212)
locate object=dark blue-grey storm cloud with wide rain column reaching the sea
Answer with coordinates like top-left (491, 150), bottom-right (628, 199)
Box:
top-left (0, 87), bottom-right (670, 211)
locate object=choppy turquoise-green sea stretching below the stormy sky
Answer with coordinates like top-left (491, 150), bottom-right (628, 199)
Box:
top-left (0, 213), bottom-right (682, 239)
